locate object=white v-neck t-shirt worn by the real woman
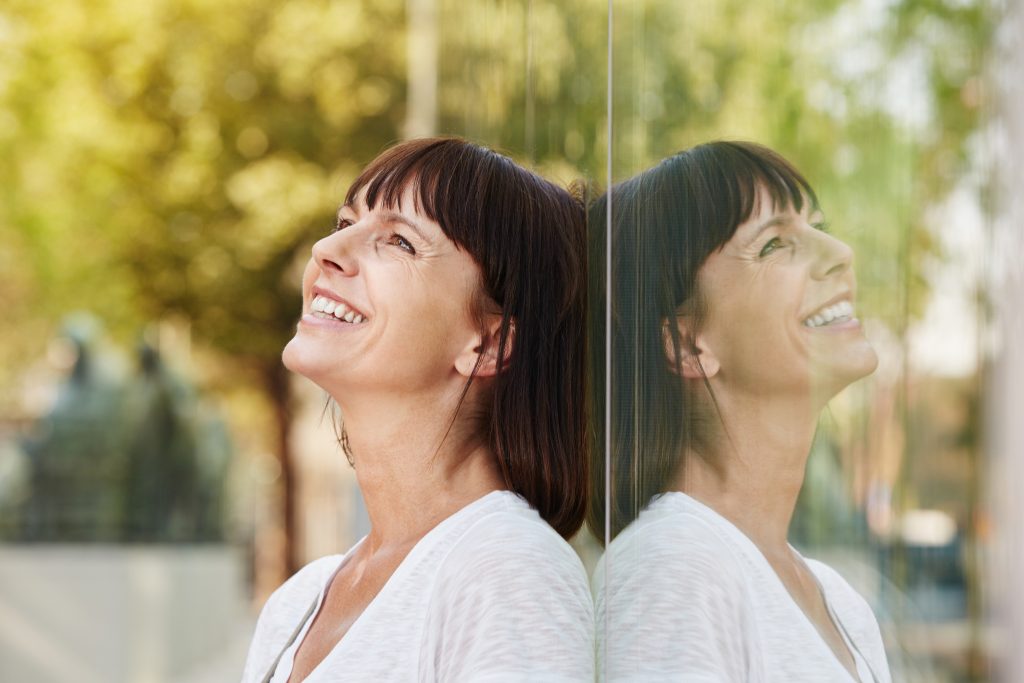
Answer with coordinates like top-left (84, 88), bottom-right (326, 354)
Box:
top-left (242, 492), bottom-right (594, 683)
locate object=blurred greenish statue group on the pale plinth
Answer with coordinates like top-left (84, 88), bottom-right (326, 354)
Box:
top-left (20, 314), bottom-right (231, 543)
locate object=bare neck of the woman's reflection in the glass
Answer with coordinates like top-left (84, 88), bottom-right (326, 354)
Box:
top-left (676, 390), bottom-right (817, 558)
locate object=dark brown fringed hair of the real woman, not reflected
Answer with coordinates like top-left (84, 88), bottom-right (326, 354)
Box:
top-left (345, 137), bottom-right (589, 538)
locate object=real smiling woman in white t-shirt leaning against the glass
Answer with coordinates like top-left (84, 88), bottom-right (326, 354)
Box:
top-left (244, 139), bottom-right (593, 682)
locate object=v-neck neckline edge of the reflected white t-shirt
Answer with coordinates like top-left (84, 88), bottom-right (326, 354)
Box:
top-left (658, 490), bottom-right (877, 683)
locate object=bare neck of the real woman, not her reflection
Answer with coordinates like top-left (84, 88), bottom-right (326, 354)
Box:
top-left (342, 387), bottom-right (506, 553)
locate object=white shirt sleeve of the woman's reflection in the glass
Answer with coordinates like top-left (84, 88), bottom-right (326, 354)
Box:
top-left (594, 520), bottom-right (757, 683)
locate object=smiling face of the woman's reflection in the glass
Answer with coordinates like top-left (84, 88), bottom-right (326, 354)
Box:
top-left (697, 190), bottom-right (878, 401)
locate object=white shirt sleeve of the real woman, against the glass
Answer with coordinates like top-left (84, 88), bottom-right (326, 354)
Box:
top-left (421, 518), bottom-right (594, 683)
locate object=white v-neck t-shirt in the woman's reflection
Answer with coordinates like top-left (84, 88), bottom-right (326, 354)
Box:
top-left (594, 493), bottom-right (891, 683)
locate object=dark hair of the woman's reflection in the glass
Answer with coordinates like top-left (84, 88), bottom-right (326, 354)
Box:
top-left (588, 141), bottom-right (818, 542)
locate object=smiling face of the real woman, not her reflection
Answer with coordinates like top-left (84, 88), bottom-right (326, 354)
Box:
top-left (284, 187), bottom-right (480, 405)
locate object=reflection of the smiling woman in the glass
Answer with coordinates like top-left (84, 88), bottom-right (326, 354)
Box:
top-left (591, 142), bottom-right (889, 682)
